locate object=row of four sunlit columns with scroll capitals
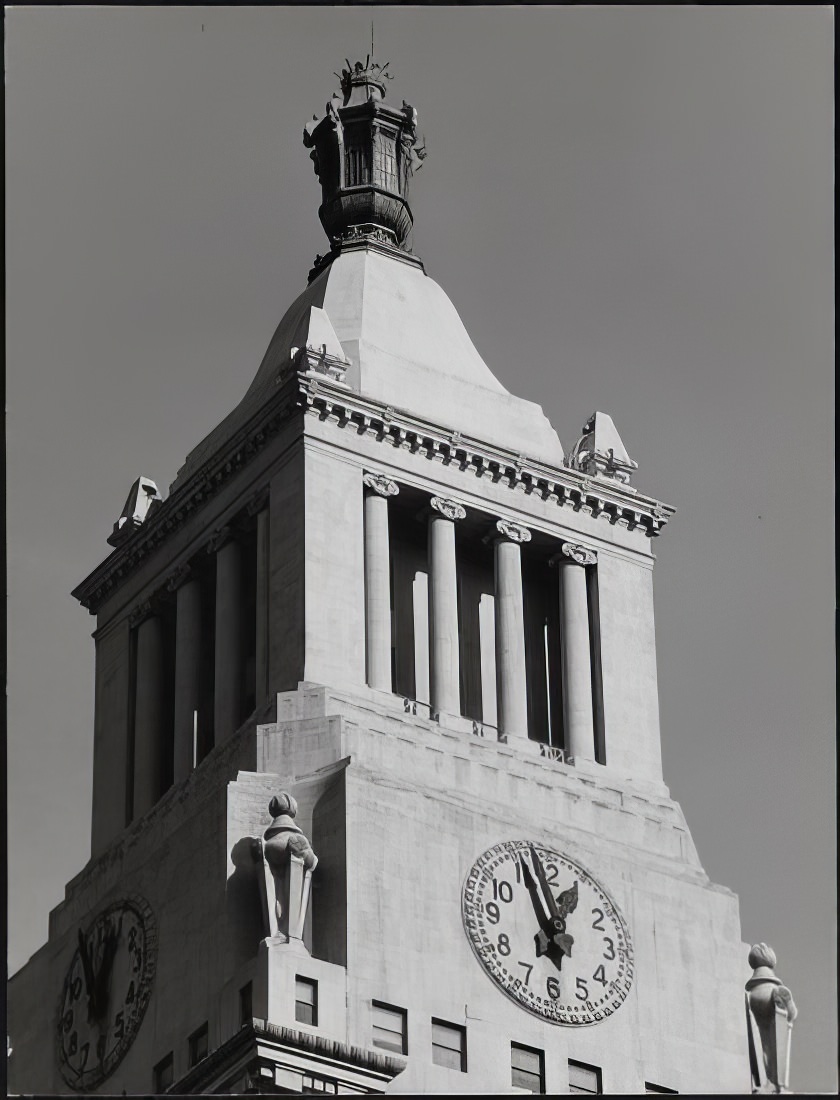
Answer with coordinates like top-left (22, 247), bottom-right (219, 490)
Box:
top-left (364, 473), bottom-right (597, 760)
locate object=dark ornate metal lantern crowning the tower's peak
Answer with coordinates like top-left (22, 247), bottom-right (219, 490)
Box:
top-left (303, 54), bottom-right (424, 275)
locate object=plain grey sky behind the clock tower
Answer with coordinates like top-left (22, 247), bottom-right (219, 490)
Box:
top-left (5, 7), bottom-right (837, 1091)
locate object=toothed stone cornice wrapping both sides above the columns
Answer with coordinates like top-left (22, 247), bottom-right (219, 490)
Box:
top-left (73, 371), bottom-right (675, 614)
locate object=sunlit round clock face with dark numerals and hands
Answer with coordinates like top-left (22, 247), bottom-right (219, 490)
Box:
top-left (462, 840), bottom-right (633, 1024)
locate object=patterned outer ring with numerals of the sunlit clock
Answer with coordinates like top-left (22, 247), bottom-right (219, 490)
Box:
top-left (461, 839), bottom-right (633, 1026)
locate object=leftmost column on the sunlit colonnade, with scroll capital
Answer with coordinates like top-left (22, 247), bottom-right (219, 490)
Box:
top-left (362, 474), bottom-right (399, 692)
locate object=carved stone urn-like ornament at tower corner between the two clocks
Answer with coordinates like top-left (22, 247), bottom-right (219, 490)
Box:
top-left (254, 791), bottom-right (318, 943)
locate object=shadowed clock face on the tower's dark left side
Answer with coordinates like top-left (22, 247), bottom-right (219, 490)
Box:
top-left (57, 897), bottom-right (157, 1091)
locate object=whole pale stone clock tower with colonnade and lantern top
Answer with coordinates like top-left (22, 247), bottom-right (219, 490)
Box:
top-left (9, 58), bottom-right (749, 1095)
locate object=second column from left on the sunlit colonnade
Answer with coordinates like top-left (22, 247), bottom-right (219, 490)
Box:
top-left (429, 496), bottom-right (466, 714)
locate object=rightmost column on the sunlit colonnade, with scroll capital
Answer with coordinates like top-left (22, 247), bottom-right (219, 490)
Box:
top-left (553, 542), bottom-right (598, 760)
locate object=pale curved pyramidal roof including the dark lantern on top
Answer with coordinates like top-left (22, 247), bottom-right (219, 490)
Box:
top-left (172, 57), bottom-right (564, 488)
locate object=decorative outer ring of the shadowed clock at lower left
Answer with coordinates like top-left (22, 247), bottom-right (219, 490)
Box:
top-left (54, 894), bottom-right (157, 1092)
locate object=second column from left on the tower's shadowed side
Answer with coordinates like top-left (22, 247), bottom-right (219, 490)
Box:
top-left (167, 565), bottom-right (201, 783)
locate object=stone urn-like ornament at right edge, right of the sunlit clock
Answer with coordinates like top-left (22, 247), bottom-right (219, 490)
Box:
top-left (745, 944), bottom-right (797, 1092)
